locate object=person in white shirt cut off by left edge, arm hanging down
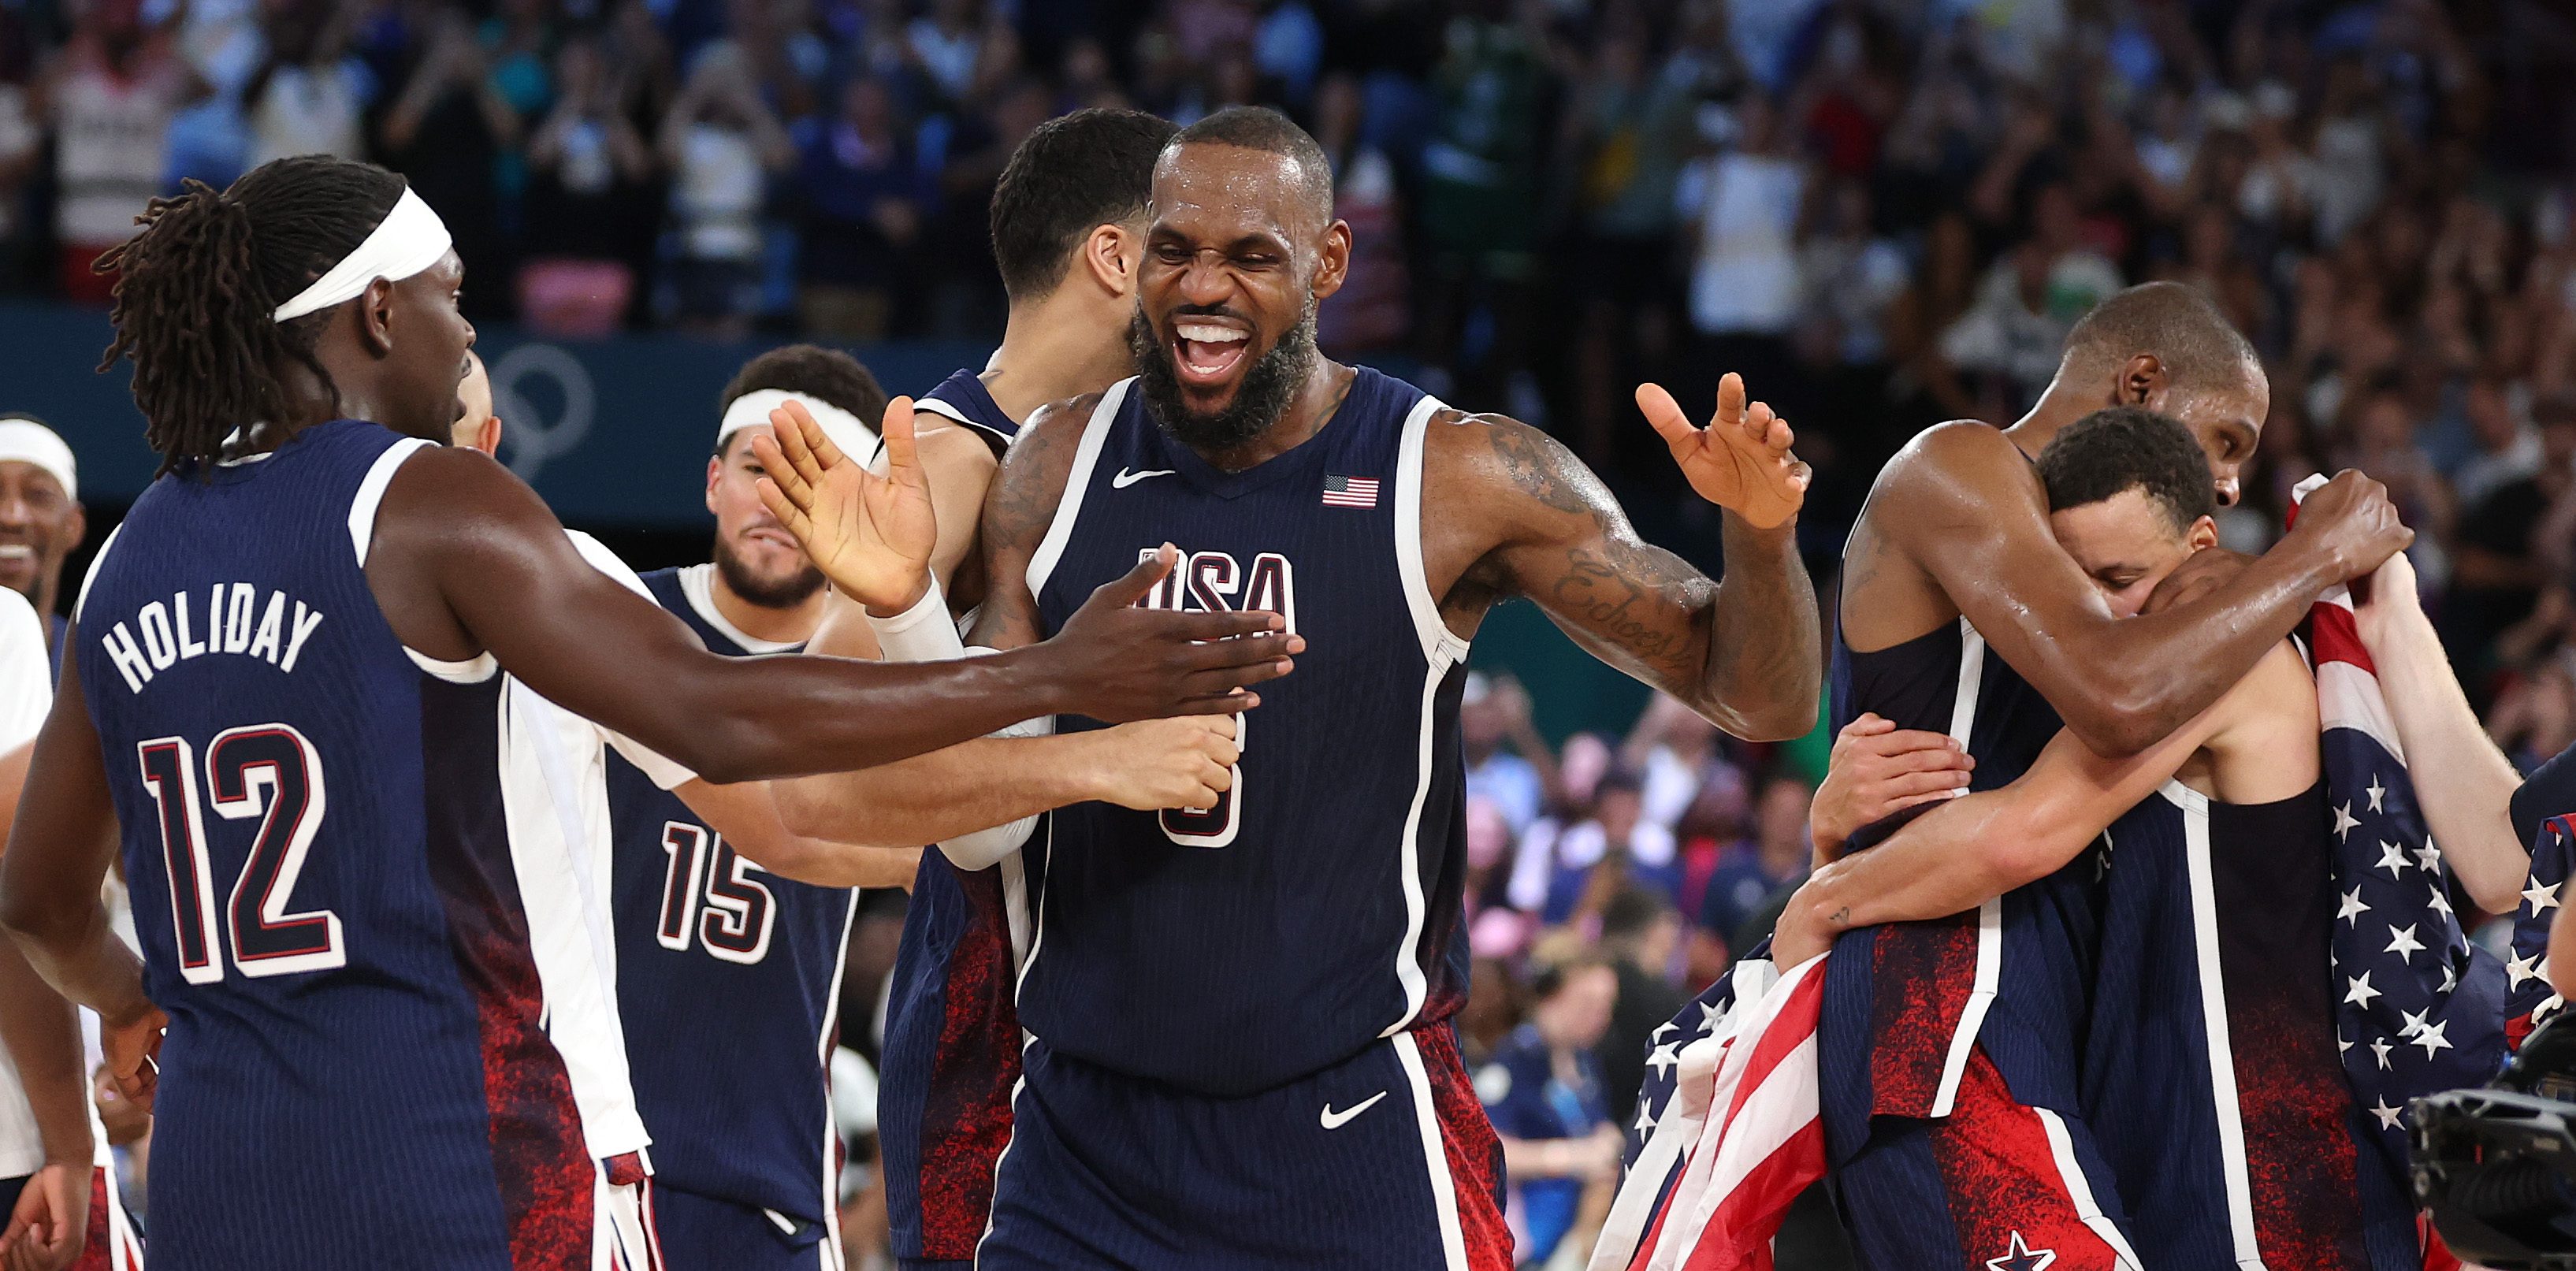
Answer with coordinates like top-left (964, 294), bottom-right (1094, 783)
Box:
top-left (0, 588), bottom-right (142, 1271)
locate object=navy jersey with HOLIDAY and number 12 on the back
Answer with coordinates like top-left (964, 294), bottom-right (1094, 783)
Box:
top-left (77, 420), bottom-right (595, 1271)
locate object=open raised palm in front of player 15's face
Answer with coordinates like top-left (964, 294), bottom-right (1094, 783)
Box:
top-left (753, 397), bottom-right (940, 616)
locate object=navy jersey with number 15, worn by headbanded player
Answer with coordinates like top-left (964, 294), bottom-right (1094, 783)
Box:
top-left (608, 565), bottom-right (858, 1240)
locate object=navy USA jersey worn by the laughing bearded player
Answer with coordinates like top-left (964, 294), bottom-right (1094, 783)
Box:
top-left (1020, 366), bottom-right (1466, 1096)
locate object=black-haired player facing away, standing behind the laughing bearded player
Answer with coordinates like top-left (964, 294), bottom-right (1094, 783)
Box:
top-left (757, 108), bottom-right (1175, 1271)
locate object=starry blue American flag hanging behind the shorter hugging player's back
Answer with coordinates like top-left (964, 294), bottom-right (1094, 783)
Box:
top-left (2292, 477), bottom-right (2504, 1170)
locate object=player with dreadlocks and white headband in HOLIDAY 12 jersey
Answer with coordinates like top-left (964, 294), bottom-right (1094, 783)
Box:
top-left (0, 158), bottom-right (1295, 1269)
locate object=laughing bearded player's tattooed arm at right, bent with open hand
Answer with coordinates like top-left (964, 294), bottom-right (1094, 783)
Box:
top-left (1425, 373), bottom-right (1823, 740)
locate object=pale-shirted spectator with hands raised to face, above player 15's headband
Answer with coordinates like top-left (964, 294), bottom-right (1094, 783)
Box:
top-left (660, 44), bottom-right (796, 340)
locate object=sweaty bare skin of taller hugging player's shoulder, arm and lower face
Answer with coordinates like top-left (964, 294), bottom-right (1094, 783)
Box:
top-left (1842, 376), bottom-right (2411, 756)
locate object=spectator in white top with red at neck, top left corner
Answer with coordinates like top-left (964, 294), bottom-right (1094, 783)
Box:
top-left (44, 0), bottom-right (195, 304)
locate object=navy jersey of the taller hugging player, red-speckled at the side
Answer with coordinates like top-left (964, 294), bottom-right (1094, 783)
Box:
top-left (1819, 619), bottom-right (2099, 1160)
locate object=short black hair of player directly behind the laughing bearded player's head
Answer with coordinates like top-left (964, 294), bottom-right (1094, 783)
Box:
top-left (992, 106), bottom-right (1172, 299)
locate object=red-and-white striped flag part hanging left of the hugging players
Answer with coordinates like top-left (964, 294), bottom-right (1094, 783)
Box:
top-left (1589, 954), bottom-right (1829, 1271)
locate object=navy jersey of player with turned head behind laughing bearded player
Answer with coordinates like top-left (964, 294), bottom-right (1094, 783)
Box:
top-left (875, 371), bottom-right (1033, 1263)
